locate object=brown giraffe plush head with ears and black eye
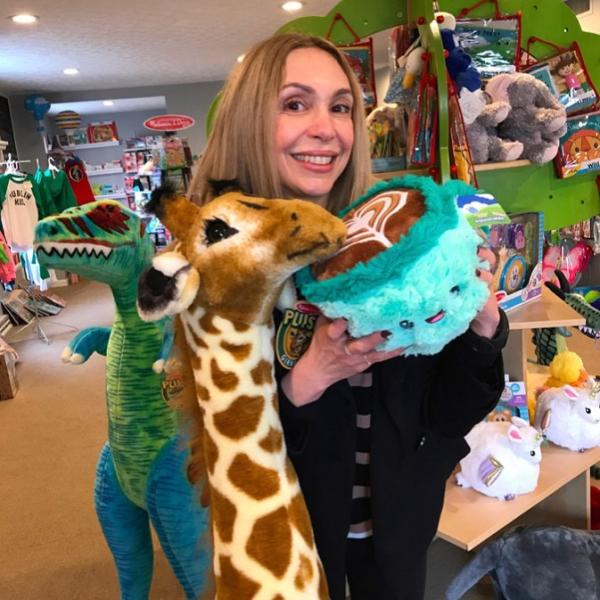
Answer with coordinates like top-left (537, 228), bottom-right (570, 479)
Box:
top-left (138, 184), bottom-right (346, 322)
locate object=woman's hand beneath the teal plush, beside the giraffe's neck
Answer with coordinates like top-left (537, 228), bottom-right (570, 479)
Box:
top-left (281, 316), bottom-right (405, 406)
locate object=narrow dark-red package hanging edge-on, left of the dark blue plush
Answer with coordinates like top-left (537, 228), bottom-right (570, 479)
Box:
top-left (407, 54), bottom-right (438, 167)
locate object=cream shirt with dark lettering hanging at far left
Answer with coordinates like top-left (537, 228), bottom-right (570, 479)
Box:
top-left (0, 175), bottom-right (44, 252)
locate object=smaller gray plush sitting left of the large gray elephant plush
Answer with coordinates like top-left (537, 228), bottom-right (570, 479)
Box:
top-left (460, 88), bottom-right (523, 165)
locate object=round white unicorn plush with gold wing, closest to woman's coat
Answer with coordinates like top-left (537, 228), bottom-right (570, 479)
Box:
top-left (456, 417), bottom-right (544, 500)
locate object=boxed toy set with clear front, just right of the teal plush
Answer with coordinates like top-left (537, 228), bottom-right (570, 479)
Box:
top-left (488, 212), bottom-right (544, 311)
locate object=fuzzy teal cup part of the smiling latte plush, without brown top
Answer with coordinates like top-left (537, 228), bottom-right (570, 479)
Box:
top-left (296, 175), bottom-right (489, 356)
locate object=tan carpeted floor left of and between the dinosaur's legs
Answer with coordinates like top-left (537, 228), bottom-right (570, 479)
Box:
top-left (0, 282), bottom-right (184, 600)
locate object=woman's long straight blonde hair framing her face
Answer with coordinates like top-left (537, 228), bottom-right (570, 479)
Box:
top-left (190, 33), bottom-right (371, 213)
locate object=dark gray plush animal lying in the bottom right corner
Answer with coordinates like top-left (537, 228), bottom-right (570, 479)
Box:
top-left (446, 526), bottom-right (600, 600)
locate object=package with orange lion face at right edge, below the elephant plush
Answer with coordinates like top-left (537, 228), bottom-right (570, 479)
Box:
top-left (555, 112), bottom-right (600, 179)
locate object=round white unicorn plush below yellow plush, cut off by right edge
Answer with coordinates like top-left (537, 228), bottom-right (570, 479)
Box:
top-left (535, 378), bottom-right (600, 452)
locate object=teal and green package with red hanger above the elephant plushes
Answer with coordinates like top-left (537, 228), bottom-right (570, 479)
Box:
top-left (454, 0), bottom-right (521, 80)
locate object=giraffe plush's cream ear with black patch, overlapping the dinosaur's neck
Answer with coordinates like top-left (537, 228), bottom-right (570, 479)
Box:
top-left (137, 252), bottom-right (200, 321)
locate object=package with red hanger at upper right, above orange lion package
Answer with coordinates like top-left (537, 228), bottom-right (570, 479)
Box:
top-left (525, 36), bottom-right (598, 116)
